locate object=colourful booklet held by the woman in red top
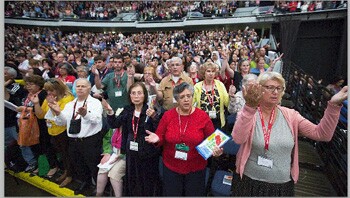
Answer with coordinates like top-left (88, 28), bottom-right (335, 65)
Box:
top-left (196, 129), bottom-right (231, 160)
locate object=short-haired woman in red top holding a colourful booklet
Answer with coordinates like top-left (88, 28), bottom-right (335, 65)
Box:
top-left (145, 82), bottom-right (222, 197)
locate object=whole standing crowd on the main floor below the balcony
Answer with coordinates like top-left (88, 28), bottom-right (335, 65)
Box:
top-left (4, 22), bottom-right (347, 196)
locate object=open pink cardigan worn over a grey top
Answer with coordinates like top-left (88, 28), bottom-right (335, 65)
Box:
top-left (232, 102), bottom-right (341, 183)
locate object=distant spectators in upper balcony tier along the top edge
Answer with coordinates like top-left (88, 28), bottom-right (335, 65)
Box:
top-left (5, 0), bottom-right (347, 21)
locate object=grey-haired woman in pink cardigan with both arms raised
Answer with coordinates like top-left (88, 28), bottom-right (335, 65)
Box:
top-left (232, 72), bottom-right (348, 197)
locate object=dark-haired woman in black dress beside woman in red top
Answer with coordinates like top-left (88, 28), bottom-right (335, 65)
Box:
top-left (97, 82), bottom-right (161, 196)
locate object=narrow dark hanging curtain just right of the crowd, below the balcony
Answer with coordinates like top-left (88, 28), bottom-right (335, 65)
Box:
top-left (280, 20), bottom-right (301, 61)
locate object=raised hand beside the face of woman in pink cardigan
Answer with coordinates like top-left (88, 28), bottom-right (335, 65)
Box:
top-left (242, 83), bottom-right (263, 108)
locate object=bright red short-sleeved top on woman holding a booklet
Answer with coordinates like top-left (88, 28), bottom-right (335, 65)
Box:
top-left (156, 108), bottom-right (215, 174)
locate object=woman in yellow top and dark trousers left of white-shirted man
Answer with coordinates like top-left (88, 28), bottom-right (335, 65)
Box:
top-left (31, 78), bottom-right (74, 187)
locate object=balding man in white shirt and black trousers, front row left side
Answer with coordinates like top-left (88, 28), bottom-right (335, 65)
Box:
top-left (49, 78), bottom-right (103, 194)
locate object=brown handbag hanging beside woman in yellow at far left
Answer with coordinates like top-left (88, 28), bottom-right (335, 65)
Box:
top-left (17, 107), bottom-right (40, 146)
